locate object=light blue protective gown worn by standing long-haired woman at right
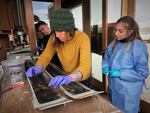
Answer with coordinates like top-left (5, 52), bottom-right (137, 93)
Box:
top-left (102, 39), bottom-right (149, 113)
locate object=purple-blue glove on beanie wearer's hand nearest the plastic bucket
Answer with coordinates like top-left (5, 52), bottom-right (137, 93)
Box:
top-left (26, 66), bottom-right (43, 77)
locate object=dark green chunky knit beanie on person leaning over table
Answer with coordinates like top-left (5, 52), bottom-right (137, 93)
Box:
top-left (50, 9), bottom-right (75, 31)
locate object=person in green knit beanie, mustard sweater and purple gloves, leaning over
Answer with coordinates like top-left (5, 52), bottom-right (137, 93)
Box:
top-left (26, 9), bottom-right (91, 88)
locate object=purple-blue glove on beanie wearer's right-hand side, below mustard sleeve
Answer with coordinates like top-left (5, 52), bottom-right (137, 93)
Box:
top-left (48, 75), bottom-right (72, 88)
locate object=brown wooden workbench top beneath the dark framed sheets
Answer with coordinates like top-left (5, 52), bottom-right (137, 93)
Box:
top-left (1, 82), bottom-right (121, 113)
